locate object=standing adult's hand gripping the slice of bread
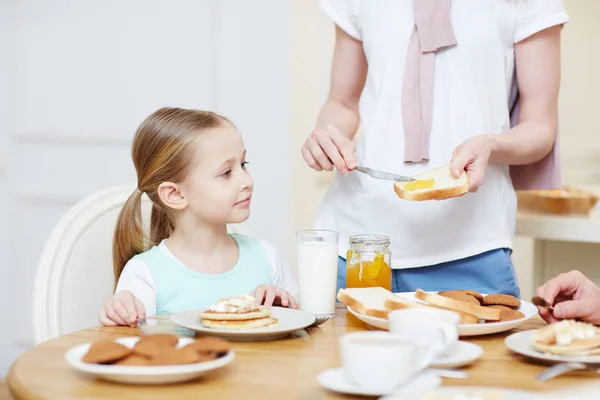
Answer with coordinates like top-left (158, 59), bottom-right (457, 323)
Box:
top-left (450, 135), bottom-right (495, 192)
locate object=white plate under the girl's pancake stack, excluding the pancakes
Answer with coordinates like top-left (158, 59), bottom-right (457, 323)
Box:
top-left (171, 307), bottom-right (315, 340)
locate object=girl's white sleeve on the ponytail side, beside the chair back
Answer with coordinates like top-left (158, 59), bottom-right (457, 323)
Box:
top-left (115, 259), bottom-right (156, 316)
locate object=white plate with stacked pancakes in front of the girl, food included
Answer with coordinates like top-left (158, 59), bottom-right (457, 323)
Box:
top-left (171, 295), bottom-right (315, 340)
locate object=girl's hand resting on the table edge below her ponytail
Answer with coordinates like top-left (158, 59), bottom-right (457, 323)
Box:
top-left (99, 290), bottom-right (146, 328)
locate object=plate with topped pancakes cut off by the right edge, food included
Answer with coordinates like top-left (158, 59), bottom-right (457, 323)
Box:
top-left (504, 320), bottom-right (600, 364)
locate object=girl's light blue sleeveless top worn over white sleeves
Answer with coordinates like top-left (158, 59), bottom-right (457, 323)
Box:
top-left (134, 234), bottom-right (273, 315)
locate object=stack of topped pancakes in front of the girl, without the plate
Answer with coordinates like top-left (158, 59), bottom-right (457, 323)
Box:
top-left (200, 295), bottom-right (279, 330)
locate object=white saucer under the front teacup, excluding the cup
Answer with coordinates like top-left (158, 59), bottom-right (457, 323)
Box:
top-left (317, 368), bottom-right (442, 397)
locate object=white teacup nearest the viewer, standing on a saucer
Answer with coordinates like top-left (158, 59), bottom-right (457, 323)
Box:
top-left (339, 332), bottom-right (435, 393)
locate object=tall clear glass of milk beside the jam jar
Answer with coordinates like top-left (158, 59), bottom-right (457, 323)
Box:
top-left (296, 230), bottom-right (339, 316)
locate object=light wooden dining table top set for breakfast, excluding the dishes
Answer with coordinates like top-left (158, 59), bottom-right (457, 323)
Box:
top-left (7, 305), bottom-right (598, 400)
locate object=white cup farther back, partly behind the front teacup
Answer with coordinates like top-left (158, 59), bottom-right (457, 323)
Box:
top-left (388, 308), bottom-right (460, 356)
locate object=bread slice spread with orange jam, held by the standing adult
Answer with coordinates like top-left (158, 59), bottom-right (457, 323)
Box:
top-left (394, 165), bottom-right (469, 201)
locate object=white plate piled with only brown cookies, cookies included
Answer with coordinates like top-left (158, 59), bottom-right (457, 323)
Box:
top-left (65, 334), bottom-right (235, 385)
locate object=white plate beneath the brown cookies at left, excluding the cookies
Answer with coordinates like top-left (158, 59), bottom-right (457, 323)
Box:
top-left (65, 337), bottom-right (235, 385)
